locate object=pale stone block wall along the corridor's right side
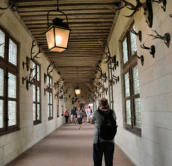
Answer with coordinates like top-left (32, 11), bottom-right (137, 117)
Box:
top-left (96, 0), bottom-right (172, 166)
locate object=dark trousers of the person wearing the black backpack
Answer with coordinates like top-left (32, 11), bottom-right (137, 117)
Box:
top-left (93, 142), bottom-right (115, 166)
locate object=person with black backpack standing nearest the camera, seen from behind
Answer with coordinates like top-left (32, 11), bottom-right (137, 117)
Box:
top-left (92, 98), bottom-right (117, 166)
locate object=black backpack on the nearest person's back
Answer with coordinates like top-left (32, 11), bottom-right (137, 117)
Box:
top-left (98, 110), bottom-right (117, 140)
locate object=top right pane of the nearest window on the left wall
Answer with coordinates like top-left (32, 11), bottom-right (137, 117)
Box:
top-left (9, 39), bottom-right (17, 65)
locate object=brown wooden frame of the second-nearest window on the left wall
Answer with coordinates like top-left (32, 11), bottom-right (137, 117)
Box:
top-left (32, 60), bottom-right (42, 125)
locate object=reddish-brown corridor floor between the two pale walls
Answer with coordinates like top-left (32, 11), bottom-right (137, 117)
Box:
top-left (8, 124), bottom-right (134, 166)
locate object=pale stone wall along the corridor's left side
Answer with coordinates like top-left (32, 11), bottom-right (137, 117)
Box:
top-left (0, 5), bottom-right (65, 166)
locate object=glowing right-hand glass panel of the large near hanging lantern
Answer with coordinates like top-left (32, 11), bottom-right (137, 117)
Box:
top-left (55, 27), bottom-right (70, 48)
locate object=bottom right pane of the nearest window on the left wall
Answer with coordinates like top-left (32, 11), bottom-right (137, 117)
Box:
top-left (8, 101), bottom-right (17, 126)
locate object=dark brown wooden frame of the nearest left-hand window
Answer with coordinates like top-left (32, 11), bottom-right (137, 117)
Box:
top-left (0, 26), bottom-right (20, 136)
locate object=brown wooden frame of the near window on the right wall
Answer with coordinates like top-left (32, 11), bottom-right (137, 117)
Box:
top-left (120, 23), bottom-right (141, 136)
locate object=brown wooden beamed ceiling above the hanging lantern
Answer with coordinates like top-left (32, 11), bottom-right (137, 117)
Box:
top-left (15, 0), bottom-right (119, 97)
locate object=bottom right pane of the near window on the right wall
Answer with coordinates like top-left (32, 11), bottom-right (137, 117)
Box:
top-left (134, 98), bottom-right (141, 128)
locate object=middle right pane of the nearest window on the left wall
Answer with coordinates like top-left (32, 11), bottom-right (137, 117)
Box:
top-left (8, 73), bottom-right (17, 98)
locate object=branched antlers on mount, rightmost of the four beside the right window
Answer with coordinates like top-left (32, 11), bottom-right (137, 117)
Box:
top-left (149, 30), bottom-right (171, 48)
